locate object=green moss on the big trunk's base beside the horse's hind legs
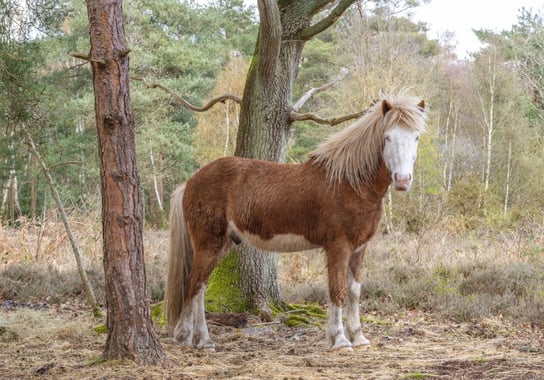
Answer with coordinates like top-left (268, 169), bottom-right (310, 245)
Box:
top-left (206, 251), bottom-right (250, 313)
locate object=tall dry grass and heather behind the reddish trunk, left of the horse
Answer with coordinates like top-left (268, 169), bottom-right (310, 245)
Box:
top-left (0, 214), bottom-right (168, 304)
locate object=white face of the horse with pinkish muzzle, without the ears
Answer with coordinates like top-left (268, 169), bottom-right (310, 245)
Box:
top-left (383, 126), bottom-right (419, 191)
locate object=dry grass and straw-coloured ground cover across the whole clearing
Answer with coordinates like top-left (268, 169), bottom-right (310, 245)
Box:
top-left (0, 215), bottom-right (544, 379)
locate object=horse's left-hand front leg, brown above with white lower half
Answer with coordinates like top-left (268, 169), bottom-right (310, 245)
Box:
top-left (325, 248), bottom-right (351, 350)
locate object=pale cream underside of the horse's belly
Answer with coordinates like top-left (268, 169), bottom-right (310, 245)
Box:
top-left (231, 225), bottom-right (318, 252)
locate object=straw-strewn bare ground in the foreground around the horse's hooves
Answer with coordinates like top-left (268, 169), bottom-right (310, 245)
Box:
top-left (0, 305), bottom-right (544, 380)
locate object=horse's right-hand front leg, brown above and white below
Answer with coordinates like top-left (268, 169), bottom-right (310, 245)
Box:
top-left (346, 246), bottom-right (370, 347)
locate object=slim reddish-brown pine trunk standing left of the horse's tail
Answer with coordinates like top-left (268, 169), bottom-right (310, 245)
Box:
top-left (87, 0), bottom-right (166, 364)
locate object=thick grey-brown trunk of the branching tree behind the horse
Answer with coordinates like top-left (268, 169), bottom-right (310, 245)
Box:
top-left (210, 0), bottom-right (355, 319)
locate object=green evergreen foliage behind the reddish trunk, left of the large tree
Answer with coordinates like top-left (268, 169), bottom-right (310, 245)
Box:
top-left (0, 0), bottom-right (257, 226)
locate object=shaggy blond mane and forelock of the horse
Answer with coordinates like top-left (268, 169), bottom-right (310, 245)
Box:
top-left (309, 95), bottom-right (425, 189)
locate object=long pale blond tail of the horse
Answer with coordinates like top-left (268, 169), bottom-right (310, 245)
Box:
top-left (165, 184), bottom-right (193, 331)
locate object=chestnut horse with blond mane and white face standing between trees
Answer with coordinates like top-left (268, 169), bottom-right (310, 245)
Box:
top-left (166, 94), bottom-right (425, 351)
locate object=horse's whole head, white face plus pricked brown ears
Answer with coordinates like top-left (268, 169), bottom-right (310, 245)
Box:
top-left (381, 100), bottom-right (425, 191)
